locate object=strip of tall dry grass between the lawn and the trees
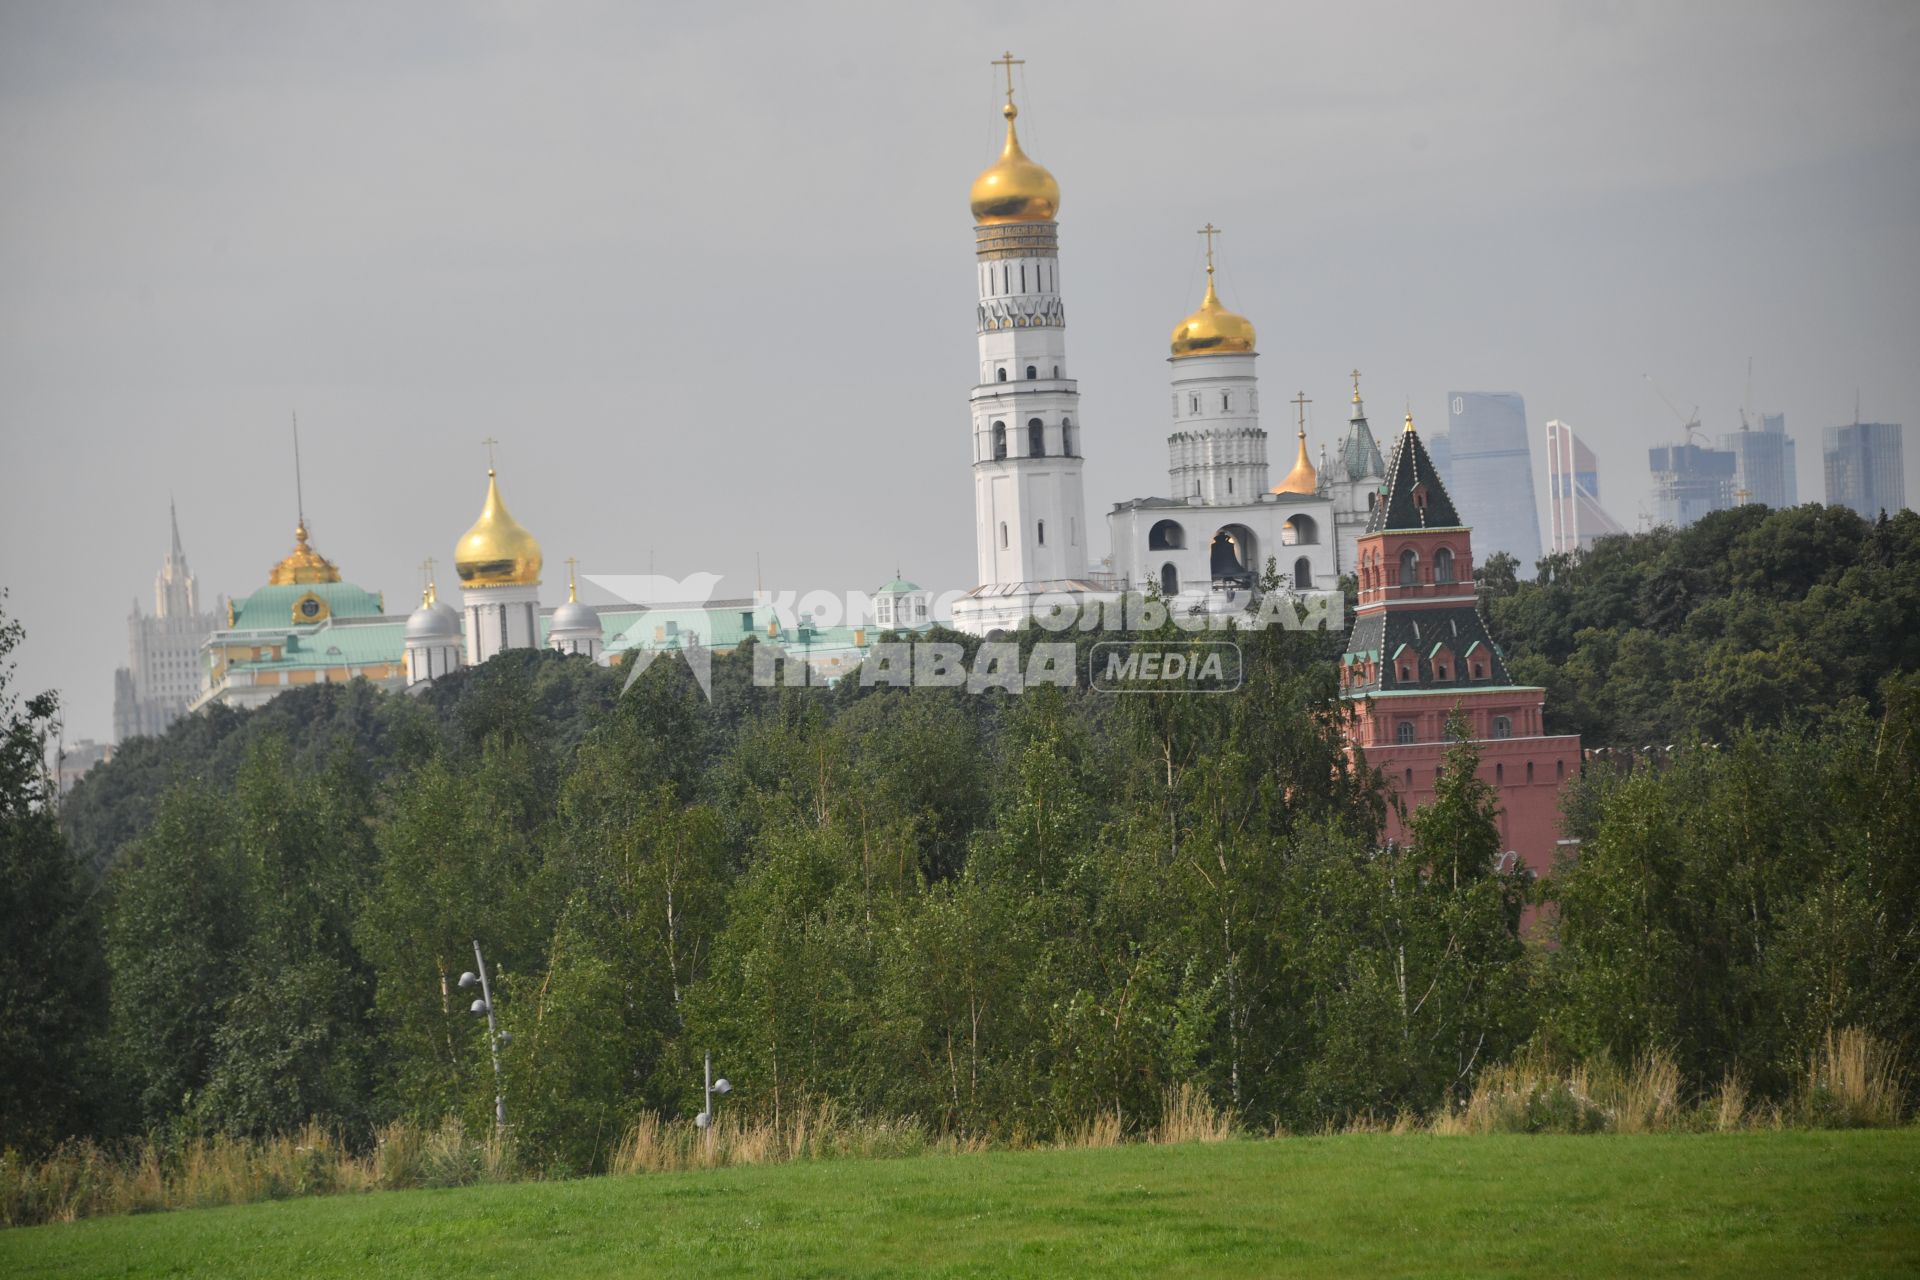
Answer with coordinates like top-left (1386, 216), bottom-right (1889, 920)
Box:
top-left (0, 1029), bottom-right (1907, 1226)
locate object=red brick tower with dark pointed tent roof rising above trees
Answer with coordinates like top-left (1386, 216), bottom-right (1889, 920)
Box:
top-left (1340, 415), bottom-right (1580, 875)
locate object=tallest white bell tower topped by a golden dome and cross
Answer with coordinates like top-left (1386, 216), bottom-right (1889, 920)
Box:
top-left (954, 54), bottom-right (1098, 633)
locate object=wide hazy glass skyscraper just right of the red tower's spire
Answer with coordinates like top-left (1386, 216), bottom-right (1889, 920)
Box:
top-left (1444, 391), bottom-right (1540, 578)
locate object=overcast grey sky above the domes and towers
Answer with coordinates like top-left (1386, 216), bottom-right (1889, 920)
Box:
top-left (0, 0), bottom-right (1920, 739)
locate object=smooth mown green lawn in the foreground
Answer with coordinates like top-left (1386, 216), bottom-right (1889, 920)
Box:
top-left (0, 1128), bottom-right (1920, 1280)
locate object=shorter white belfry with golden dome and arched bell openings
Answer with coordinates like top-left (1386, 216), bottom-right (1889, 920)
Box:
top-left (1108, 223), bottom-right (1338, 612)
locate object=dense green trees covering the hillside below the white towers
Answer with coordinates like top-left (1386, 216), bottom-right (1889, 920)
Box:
top-left (0, 507), bottom-right (1920, 1171)
